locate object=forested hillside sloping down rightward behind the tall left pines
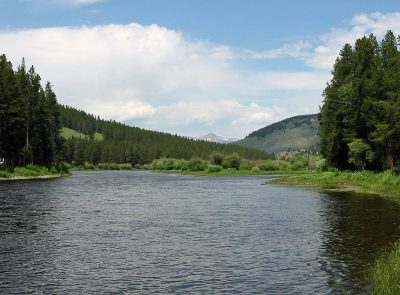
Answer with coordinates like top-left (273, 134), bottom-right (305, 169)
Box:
top-left (60, 106), bottom-right (272, 165)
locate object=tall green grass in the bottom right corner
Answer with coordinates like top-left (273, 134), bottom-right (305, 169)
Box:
top-left (371, 241), bottom-right (400, 295)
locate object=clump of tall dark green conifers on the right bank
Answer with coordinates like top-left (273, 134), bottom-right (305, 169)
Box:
top-left (319, 31), bottom-right (400, 170)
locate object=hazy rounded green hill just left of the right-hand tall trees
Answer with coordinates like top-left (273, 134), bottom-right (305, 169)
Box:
top-left (235, 114), bottom-right (320, 154)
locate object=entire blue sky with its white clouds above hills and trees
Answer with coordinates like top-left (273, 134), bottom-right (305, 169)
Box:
top-left (0, 0), bottom-right (400, 138)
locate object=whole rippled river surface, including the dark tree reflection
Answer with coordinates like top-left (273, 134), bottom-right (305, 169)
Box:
top-left (0, 171), bottom-right (400, 294)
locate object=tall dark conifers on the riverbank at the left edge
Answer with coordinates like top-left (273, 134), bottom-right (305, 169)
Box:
top-left (0, 55), bottom-right (62, 166)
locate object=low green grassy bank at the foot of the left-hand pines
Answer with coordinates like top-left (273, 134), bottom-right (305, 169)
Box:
top-left (0, 164), bottom-right (71, 180)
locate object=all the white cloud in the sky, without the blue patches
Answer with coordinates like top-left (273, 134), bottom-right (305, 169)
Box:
top-left (0, 13), bottom-right (394, 137)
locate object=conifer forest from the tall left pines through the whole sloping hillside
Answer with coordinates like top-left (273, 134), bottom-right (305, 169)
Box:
top-left (0, 54), bottom-right (273, 167)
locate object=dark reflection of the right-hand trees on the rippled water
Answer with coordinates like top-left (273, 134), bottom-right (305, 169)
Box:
top-left (320, 192), bottom-right (400, 294)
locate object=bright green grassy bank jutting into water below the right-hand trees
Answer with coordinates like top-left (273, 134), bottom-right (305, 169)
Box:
top-left (273, 171), bottom-right (400, 200)
